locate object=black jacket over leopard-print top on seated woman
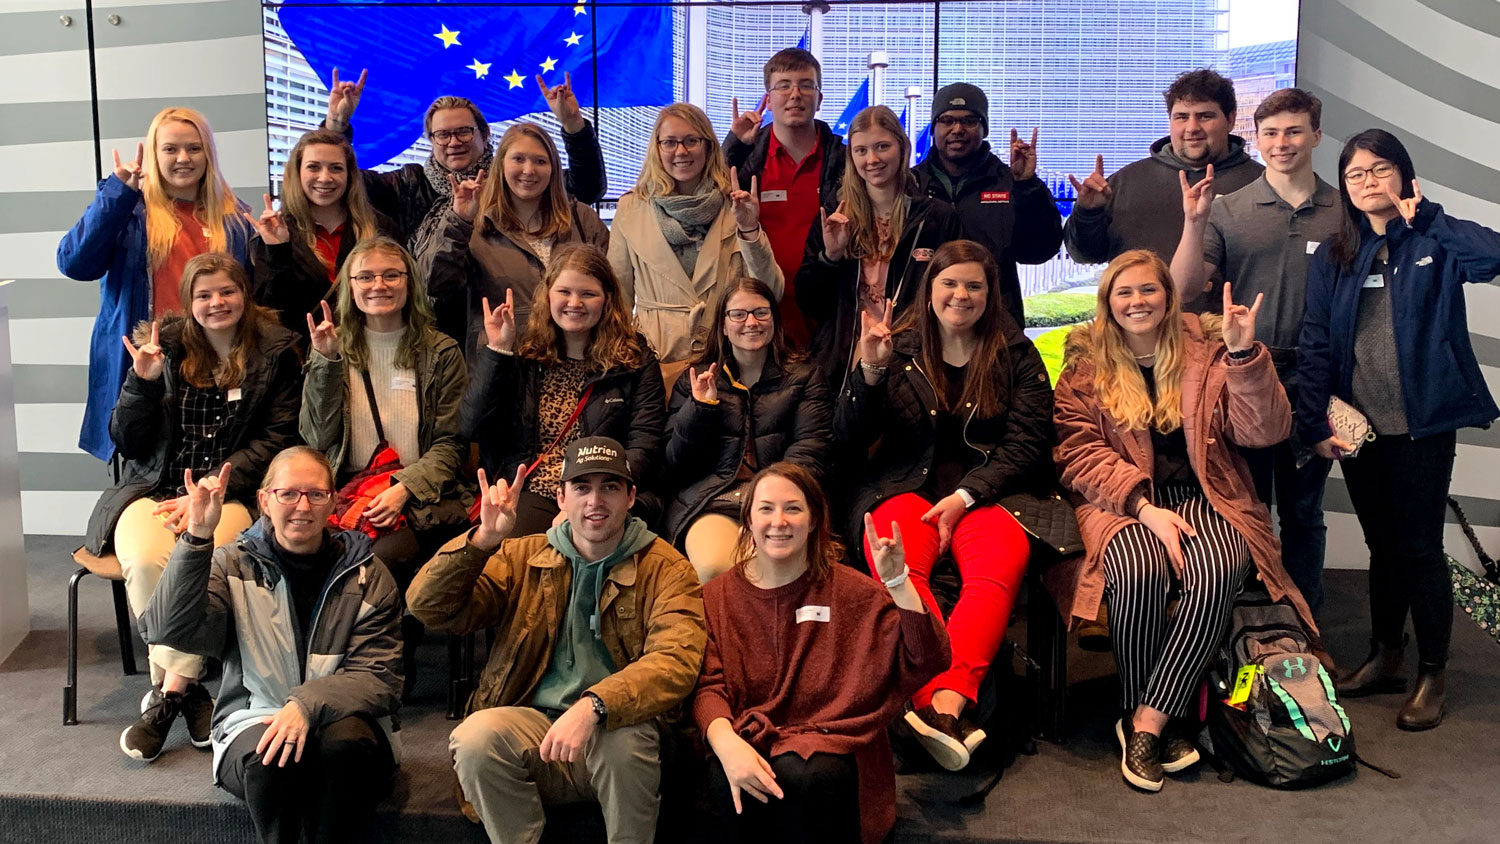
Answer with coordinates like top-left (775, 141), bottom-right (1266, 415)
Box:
top-left (462, 334), bottom-right (666, 516)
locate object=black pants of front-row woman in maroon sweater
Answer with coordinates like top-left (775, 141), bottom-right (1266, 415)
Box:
top-left (708, 753), bottom-right (860, 844)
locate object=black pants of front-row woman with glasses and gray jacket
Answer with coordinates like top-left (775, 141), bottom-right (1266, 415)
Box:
top-left (219, 715), bottom-right (396, 844)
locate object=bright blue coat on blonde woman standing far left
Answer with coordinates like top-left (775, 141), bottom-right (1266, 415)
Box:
top-left (57, 174), bottom-right (251, 460)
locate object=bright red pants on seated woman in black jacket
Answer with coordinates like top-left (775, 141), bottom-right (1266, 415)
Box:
top-left (864, 492), bottom-right (1031, 709)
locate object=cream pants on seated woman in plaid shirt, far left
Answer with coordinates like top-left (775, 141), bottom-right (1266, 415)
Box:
top-left (113, 498), bottom-right (251, 685)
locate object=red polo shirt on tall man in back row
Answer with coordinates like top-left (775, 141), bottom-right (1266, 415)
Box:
top-left (761, 130), bottom-right (824, 349)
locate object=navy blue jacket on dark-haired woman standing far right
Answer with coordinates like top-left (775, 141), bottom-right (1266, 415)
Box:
top-left (1296, 199), bottom-right (1500, 445)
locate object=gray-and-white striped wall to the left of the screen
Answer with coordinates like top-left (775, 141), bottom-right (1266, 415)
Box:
top-left (0, 0), bottom-right (267, 534)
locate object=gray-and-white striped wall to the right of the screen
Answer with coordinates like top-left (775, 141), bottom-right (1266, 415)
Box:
top-left (1298, 0), bottom-right (1500, 568)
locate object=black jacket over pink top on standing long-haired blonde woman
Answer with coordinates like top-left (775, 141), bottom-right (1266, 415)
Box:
top-left (792, 196), bottom-right (963, 390)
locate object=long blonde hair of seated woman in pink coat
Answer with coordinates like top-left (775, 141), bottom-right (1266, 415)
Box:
top-left (1089, 249), bottom-right (1185, 433)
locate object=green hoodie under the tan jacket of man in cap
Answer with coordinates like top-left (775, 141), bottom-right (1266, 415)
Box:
top-left (531, 516), bottom-right (657, 709)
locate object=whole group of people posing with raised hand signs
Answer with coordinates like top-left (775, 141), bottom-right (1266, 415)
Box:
top-left (59, 49), bottom-right (1500, 843)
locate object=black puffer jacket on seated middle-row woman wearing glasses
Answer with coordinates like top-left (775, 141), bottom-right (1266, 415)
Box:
top-left (663, 360), bottom-right (834, 543)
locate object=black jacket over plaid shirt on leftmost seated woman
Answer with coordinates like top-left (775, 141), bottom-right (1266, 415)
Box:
top-left (84, 316), bottom-right (302, 555)
